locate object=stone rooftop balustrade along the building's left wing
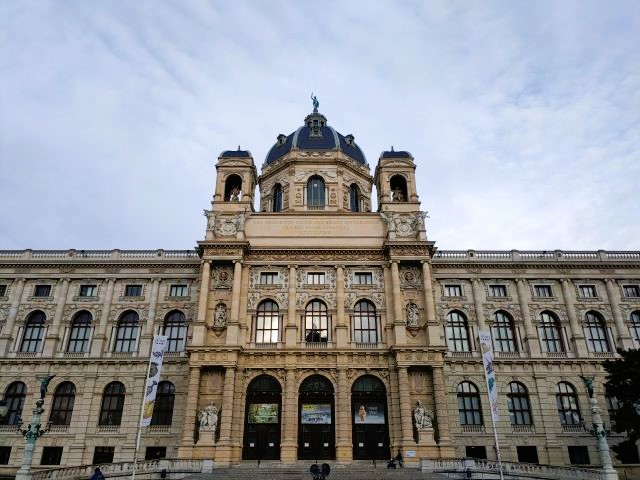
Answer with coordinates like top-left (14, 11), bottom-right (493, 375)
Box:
top-left (0, 249), bottom-right (198, 260)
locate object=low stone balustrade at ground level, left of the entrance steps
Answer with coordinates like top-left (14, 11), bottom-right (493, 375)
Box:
top-left (31, 459), bottom-right (204, 480)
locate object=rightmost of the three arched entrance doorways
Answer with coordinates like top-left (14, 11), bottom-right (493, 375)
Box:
top-left (351, 375), bottom-right (391, 460)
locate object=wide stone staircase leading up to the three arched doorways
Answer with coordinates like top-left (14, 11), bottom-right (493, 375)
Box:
top-left (185, 461), bottom-right (447, 480)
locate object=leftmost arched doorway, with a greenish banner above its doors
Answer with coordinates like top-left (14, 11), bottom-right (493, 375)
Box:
top-left (242, 375), bottom-right (282, 460)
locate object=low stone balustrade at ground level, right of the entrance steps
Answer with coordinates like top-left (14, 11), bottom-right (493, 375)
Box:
top-left (420, 458), bottom-right (602, 480)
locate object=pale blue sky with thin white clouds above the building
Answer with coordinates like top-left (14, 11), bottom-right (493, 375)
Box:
top-left (0, 0), bottom-right (640, 250)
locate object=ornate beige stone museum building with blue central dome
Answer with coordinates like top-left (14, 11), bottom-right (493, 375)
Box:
top-left (0, 105), bottom-right (640, 473)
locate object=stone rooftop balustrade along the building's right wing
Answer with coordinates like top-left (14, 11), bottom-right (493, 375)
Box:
top-left (433, 250), bottom-right (640, 262)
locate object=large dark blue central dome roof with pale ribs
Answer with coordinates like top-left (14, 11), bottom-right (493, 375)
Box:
top-left (264, 113), bottom-right (368, 166)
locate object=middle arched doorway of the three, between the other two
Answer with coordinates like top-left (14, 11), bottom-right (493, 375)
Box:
top-left (298, 375), bottom-right (336, 460)
